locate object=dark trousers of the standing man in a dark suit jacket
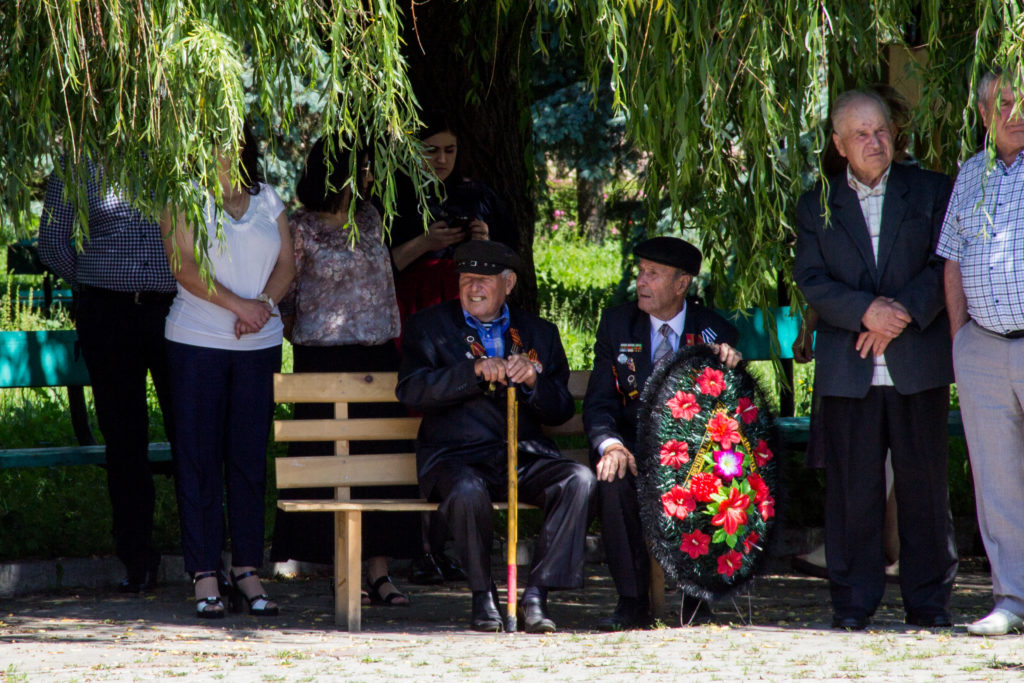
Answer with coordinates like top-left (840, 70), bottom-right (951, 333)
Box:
top-left (821, 387), bottom-right (957, 616)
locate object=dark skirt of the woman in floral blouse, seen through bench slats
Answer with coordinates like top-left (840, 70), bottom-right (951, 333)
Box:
top-left (270, 342), bottom-right (423, 564)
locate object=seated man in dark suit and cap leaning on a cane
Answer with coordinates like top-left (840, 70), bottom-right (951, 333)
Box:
top-left (396, 241), bottom-right (596, 633)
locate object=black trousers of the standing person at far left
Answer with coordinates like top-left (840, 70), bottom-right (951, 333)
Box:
top-left (76, 287), bottom-right (174, 577)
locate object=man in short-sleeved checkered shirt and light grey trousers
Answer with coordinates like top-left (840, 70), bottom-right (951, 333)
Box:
top-left (937, 73), bottom-right (1024, 636)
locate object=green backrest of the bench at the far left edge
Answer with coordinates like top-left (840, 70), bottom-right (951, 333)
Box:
top-left (0, 330), bottom-right (90, 388)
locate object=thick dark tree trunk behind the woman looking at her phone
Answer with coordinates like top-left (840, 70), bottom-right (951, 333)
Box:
top-left (406, 0), bottom-right (538, 311)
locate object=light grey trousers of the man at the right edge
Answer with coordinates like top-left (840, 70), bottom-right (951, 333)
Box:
top-left (953, 322), bottom-right (1024, 616)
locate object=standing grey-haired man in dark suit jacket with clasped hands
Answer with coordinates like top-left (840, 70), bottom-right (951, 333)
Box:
top-left (794, 91), bottom-right (956, 630)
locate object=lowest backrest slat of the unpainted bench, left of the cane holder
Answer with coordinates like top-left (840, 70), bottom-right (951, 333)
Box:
top-left (275, 453), bottom-right (419, 488)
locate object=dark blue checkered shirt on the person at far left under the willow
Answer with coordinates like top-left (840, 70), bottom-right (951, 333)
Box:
top-left (39, 162), bottom-right (176, 293)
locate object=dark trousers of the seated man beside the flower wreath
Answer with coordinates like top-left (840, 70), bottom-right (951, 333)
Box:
top-left (597, 472), bottom-right (650, 601)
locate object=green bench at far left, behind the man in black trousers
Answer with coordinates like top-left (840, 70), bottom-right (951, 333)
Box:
top-left (0, 330), bottom-right (171, 469)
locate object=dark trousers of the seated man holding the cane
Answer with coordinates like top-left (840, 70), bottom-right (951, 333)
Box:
top-left (422, 454), bottom-right (596, 591)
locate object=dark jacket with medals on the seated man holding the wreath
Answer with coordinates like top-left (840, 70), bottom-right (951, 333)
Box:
top-left (583, 300), bottom-right (739, 462)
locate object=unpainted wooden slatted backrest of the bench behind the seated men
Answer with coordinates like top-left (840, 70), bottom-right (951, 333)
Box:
top-left (273, 372), bottom-right (590, 500)
